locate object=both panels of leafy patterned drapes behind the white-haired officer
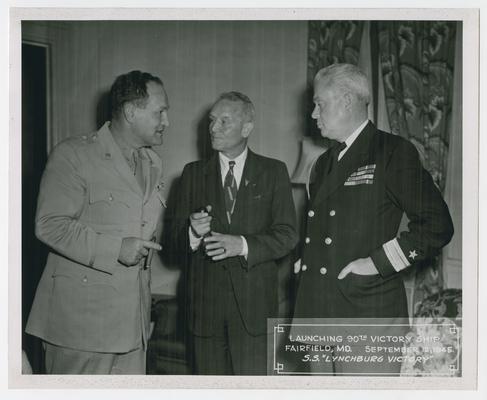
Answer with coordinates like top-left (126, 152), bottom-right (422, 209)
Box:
top-left (308, 21), bottom-right (456, 314)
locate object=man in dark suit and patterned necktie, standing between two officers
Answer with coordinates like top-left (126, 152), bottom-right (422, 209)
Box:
top-left (176, 92), bottom-right (297, 375)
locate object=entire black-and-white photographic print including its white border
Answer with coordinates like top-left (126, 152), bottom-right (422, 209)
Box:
top-left (8, 3), bottom-right (481, 390)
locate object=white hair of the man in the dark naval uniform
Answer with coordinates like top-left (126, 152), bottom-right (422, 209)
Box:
top-left (314, 64), bottom-right (370, 104)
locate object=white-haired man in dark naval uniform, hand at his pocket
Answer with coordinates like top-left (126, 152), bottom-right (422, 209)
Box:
top-left (294, 64), bottom-right (453, 372)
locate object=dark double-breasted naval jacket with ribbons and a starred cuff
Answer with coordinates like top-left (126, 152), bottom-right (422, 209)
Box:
top-left (294, 123), bottom-right (453, 318)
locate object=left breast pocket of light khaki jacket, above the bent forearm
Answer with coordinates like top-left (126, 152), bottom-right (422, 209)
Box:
top-left (86, 184), bottom-right (136, 224)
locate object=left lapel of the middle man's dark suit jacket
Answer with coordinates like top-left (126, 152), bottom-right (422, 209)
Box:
top-left (202, 153), bottom-right (228, 233)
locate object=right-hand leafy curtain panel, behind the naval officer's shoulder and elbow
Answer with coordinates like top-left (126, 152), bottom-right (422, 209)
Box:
top-left (378, 21), bottom-right (456, 309)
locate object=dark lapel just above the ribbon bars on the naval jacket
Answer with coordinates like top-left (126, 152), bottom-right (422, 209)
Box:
top-left (313, 122), bottom-right (375, 204)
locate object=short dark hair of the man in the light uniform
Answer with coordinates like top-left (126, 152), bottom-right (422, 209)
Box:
top-left (110, 71), bottom-right (164, 118)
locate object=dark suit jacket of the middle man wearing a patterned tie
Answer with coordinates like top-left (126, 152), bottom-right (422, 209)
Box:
top-left (174, 150), bottom-right (297, 335)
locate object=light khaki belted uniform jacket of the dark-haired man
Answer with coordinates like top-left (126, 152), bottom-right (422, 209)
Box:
top-left (26, 123), bottom-right (164, 353)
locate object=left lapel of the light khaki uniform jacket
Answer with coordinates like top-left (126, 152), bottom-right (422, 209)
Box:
top-left (98, 124), bottom-right (143, 196)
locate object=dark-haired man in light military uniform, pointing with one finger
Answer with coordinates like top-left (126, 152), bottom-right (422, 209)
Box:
top-left (26, 71), bottom-right (169, 374)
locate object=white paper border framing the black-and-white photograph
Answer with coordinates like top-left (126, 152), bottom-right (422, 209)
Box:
top-left (8, 8), bottom-right (480, 390)
